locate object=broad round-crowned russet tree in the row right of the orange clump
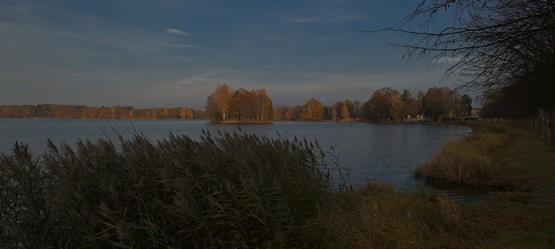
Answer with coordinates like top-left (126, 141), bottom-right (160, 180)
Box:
top-left (366, 87), bottom-right (404, 120)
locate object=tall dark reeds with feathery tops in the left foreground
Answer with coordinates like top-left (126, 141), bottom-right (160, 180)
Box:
top-left (0, 133), bottom-right (331, 248)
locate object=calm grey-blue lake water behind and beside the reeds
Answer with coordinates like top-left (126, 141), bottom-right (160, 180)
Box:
top-left (0, 119), bottom-right (484, 202)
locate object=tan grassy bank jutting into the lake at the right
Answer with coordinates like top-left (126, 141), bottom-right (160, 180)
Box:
top-left (416, 122), bottom-right (555, 191)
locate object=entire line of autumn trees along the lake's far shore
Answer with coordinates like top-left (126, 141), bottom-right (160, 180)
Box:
top-left (0, 84), bottom-right (472, 123)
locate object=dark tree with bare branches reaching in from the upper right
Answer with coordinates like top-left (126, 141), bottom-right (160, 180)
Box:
top-left (378, 0), bottom-right (555, 115)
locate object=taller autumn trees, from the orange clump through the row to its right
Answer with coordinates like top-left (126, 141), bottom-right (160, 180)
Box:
top-left (206, 84), bottom-right (472, 122)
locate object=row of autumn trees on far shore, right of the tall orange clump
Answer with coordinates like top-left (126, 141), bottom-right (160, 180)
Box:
top-left (273, 87), bottom-right (472, 122)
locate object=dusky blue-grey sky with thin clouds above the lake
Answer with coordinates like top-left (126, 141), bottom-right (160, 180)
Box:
top-left (0, 0), bottom-right (456, 108)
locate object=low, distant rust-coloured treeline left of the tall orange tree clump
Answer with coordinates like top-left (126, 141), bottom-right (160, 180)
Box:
top-left (0, 104), bottom-right (203, 119)
